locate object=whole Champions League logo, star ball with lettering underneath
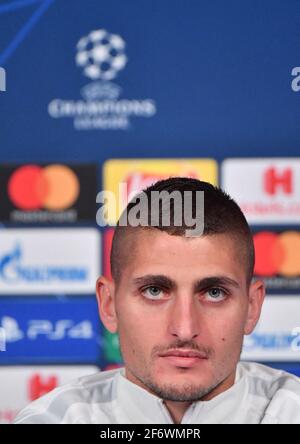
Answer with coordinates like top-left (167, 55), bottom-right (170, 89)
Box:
top-left (48, 29), bottom-right (157, 130)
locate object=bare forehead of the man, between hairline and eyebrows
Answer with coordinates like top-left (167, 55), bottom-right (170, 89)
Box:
top-left (122, 230), bottom-right (246, 281)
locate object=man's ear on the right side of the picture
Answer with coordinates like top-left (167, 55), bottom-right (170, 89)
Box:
top-left (244, 281), bottom-right (266, 335)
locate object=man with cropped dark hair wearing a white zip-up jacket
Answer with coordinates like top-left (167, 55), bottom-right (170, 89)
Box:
top-left (16, 178), bottom-right (300, 424)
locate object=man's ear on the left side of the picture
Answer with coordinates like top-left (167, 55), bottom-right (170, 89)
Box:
top-left (96, 276), bottom-right (118, 333)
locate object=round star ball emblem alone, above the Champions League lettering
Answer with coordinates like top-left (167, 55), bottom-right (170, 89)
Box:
top-left (76, 29), bottom-right (127, 80)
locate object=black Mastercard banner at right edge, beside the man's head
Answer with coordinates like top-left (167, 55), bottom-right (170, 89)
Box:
top-left (253, 230), bottom-right (300, 293)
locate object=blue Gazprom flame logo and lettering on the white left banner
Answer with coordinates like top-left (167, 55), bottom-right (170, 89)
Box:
top-left (0, 243), bottom-right (88, 283)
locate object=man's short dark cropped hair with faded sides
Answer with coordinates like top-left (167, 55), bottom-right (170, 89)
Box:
top-left (110, 177), bottom-right (255, 285)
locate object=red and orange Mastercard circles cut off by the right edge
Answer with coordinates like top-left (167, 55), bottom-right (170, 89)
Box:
top-left (253, 231), bottom-right (300, 277)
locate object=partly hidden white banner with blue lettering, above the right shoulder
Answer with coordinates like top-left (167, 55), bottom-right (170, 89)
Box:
top-left (241, 296), bottom-right (300, 362)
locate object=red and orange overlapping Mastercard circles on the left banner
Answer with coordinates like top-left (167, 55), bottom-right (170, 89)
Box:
top-left (8, 164), bottom-right (80, 211)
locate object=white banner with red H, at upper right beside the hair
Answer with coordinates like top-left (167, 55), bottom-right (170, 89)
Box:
top-left (221, 158), bottom-right (300, 225)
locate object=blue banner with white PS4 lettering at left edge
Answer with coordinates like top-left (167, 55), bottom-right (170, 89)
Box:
top-left (0, 296), bottom-right (102, 365)
